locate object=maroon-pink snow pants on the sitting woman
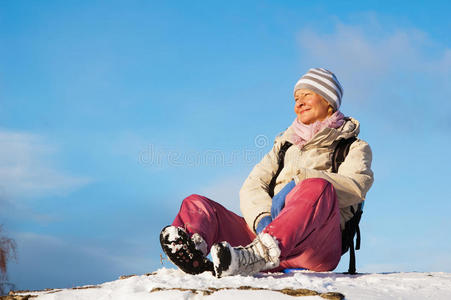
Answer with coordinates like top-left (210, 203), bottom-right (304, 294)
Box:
top-left (172, 178), bottom-right (341, 271)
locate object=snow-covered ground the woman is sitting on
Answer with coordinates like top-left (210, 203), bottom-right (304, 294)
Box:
top-left (9, 268), bottom-right (451, 300)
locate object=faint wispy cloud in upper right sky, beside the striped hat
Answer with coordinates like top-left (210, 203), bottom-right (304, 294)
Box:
top-left (298, 20), bottom-right (451, 123)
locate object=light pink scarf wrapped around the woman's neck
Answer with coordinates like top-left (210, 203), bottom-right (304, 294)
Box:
top-left (291, 110), bottom-right (345, 148)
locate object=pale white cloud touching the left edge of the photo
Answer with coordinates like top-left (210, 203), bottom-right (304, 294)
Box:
top-left (0, 129), bottom-right (90, 201)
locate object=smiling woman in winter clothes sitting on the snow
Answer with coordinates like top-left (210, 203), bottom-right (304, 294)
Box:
top-left (160, 68), bottom-right (373, 277)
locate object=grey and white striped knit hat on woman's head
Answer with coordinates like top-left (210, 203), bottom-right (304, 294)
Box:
top-left (294, 68), bottom-right (343, 111)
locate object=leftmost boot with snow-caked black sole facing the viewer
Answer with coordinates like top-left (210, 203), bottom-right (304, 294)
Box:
top-left (160, 226), bottom-right (214, 275)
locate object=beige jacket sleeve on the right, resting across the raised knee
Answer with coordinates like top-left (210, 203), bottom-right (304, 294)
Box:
top-left (294, 140), bottom-right (374, 208)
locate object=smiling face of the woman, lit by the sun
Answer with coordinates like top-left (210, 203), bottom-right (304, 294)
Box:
top-left (294, 89), bottom-right (333, 125)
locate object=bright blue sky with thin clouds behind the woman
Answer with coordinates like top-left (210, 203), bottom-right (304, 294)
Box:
top-left (0, 1), bottom-right (451, 289)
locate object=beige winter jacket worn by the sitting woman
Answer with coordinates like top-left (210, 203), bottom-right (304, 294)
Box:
top-left (240, 118), bottom-right (374, 231)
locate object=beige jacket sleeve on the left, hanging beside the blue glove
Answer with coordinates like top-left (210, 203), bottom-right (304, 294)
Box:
top-left (240, 140), bottom-right (281, 232)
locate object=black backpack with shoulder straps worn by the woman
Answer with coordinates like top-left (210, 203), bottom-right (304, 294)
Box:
top-left (268, 137), bottom-right (363, 274)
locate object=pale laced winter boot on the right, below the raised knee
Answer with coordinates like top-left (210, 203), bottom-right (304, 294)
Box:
top-left (211, 233), bottom-right (280, 277)
